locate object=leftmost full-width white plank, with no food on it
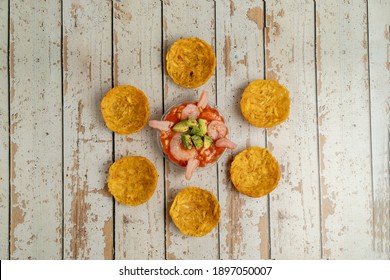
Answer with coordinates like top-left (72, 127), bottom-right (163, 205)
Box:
top-left (9, 1), bottom-right (62, 259)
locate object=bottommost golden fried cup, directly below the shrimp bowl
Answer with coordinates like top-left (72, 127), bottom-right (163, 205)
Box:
top-left (169, 187), bottom-right (221, 237)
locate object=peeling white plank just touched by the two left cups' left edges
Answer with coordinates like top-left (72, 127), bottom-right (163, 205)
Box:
top-left (63, 0), bottom-right (113, 259)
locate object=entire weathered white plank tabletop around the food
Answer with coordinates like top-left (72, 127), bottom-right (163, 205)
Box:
top-left (0, 0), bottom-right (390, 259)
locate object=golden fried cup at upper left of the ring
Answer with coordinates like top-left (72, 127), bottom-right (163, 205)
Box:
top-left (100, 86), bottom-right (150, 134)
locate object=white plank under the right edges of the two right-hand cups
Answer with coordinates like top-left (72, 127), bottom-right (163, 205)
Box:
top-left (266, 0), bottom-right (321, 259)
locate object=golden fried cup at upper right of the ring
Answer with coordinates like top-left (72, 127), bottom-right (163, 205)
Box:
top-left (240, 80), bottom-right (290, 127)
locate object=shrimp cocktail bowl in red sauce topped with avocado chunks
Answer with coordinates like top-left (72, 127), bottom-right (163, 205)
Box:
top-left (149, 91), bottom-right (236, 180)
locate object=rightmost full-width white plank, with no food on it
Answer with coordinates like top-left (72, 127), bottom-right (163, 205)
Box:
top-left (316, 0), bottom-right (374, 259)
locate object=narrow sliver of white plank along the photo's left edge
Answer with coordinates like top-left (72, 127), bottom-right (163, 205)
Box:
top-left (0, 1), bottom-right (9, 260)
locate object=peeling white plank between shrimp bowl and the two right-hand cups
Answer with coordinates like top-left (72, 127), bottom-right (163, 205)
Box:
top-left (216, 1), bottom-right (269, 259)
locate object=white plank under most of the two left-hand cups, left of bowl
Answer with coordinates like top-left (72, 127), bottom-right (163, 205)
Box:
top-left (114, 0), bottom-right (165, 259)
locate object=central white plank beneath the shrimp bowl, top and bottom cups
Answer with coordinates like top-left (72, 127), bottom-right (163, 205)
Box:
top-left (163, 1), bottom-right (219, 259)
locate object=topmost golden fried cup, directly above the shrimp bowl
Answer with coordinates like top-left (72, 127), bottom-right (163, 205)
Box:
top-left (167, 38), bottom-right (216, 88)
